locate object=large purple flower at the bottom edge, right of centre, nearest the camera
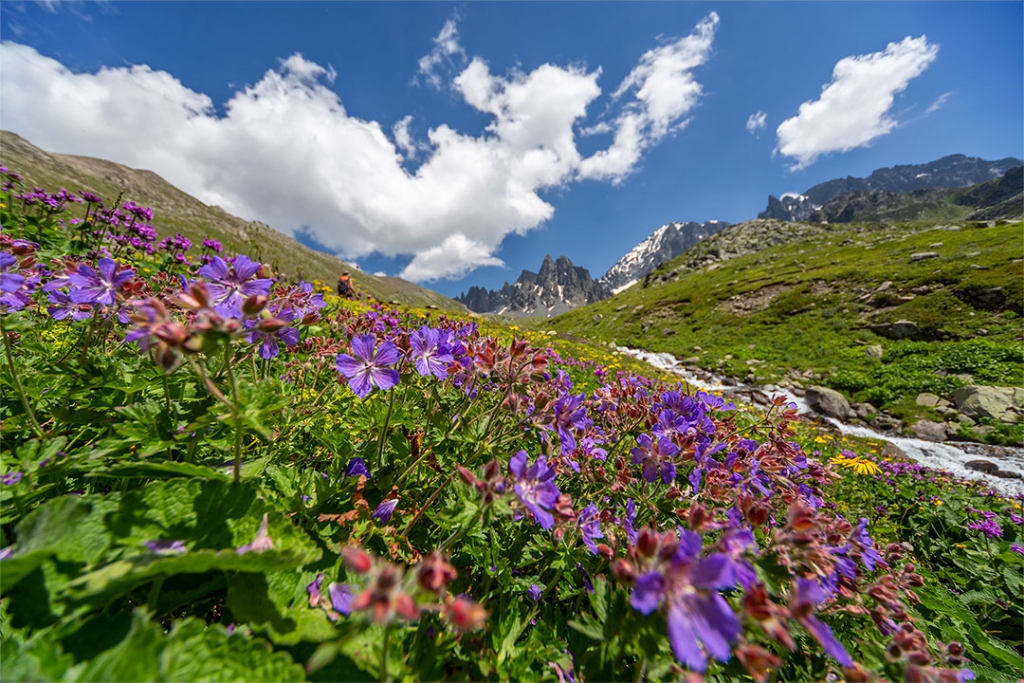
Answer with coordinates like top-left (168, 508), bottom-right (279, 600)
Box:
top-left (630, 530), bottom-right (740, 672)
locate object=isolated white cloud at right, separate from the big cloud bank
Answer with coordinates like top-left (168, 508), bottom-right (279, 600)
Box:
top-left (775, 36), bottom-right (939, 170)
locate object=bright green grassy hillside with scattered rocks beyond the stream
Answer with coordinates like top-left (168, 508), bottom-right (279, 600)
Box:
top-left (536, 216), bottom-right (1024, 436)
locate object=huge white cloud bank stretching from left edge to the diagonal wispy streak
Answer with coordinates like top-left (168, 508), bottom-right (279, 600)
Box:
top-left (0, 17), bottom-right (717, 282)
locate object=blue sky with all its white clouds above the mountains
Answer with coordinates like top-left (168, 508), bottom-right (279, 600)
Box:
top-left (0, 0), bottom-right (1024, 295)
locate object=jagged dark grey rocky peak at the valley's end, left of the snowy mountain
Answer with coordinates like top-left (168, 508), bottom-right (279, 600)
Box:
top-left (456, 254), bottom-right (609, 317)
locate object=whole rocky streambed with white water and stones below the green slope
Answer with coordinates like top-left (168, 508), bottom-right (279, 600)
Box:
top-left (615, 346), bottom-right (1024, 496)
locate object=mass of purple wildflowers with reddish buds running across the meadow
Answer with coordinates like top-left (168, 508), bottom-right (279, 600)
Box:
top-left (0, 178), bottom-right (991, 681)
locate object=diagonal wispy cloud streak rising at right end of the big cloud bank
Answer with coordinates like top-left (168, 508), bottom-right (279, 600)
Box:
top-left (579, 12), bottom-right (719, 183)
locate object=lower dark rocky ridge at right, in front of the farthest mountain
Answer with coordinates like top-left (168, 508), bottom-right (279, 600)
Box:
top-left (809, 166), bottom-right (1024, 223)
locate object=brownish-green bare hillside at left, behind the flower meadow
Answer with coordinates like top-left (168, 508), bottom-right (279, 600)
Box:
top-left (0, 131), bottom-right (465, 311)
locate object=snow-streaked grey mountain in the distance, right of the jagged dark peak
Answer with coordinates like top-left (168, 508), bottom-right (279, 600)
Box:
top-left (598, 220), bottom-right (729, 294)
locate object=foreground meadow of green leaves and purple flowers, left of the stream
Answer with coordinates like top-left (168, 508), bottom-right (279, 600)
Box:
top-left (0, 169), bottom-right (1024, 682)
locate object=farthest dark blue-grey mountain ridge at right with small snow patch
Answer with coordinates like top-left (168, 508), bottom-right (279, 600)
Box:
top-left (758, 155), bottom-right (1024, 221)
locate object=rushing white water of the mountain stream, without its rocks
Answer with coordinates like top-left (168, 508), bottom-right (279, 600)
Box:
top-left (616, 346), bottom-right (1024, 496)
